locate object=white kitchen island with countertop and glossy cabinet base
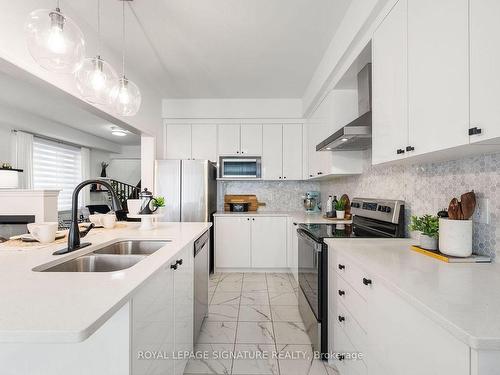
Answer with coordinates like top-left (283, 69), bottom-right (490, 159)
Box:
top-left (0, 223), bottom-right (211, 375)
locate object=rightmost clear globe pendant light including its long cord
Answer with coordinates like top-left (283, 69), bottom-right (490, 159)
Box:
top-left (109, 0), bottom-right (142, 116)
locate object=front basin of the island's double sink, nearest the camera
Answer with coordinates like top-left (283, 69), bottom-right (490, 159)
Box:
top-left (40, 254), bottom-right (146, 272)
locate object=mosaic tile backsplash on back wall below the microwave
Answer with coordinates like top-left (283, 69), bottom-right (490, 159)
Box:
top-left (217, 181), bottom-right (320, 211)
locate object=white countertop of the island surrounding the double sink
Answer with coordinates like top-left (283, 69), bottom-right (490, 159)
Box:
top-left (0, 223), bottom-right (211, 343)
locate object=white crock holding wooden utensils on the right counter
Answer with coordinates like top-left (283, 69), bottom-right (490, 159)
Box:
top-left (439, 218), bottom-right (472, 258)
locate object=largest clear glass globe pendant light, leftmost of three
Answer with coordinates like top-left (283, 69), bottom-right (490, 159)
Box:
top-left (24, 1), bottom-right (85, 73)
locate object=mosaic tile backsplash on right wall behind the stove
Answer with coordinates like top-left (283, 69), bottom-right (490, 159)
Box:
top-left (321, 153), bottom-right (500, 257)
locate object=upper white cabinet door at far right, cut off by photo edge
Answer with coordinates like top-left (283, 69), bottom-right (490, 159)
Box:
top-left (470, 0), bottom-right (500, 144)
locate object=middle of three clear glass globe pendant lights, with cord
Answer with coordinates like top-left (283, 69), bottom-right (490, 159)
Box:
top-left (76, 0), bottom-right (117, 105)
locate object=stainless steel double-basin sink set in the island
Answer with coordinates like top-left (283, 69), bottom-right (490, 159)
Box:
top-left (34, 240), bottom-right (171, 272)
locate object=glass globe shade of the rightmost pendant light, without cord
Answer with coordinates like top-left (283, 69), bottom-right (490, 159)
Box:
top-left (110, 76), bottom-right (142, 116)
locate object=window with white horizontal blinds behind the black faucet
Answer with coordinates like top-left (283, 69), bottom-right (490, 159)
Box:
top-left (33, 137), bottom-right (82, 211)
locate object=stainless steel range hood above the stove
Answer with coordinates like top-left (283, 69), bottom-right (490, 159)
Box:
top-left (316, 64), bottom-right (372, 151)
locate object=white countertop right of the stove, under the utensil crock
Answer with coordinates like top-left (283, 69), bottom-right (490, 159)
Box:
top-left (326, 239), bottom-right (500, 350)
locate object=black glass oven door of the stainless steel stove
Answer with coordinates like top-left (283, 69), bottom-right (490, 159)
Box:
top-left (297, 229), bottom-right (323, 322)
